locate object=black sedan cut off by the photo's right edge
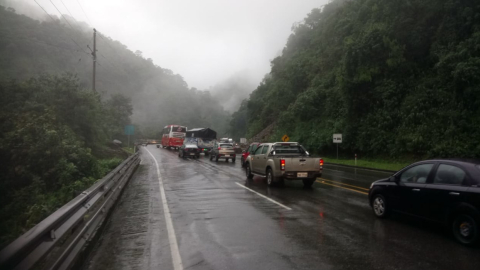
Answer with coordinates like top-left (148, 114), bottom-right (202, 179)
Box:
top-left (368, 160), bottom-right (480, 245)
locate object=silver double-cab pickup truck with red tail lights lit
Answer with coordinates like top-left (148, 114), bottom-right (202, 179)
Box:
top-left (245, 142), bottom-right (323, 187)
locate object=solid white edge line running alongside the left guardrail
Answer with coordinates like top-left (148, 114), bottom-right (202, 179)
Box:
top-left (145, 148), bottom-right (183, 270)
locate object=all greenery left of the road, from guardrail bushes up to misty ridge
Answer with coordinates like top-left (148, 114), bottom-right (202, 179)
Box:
top-left (0, 0), bottom-right (229, 247)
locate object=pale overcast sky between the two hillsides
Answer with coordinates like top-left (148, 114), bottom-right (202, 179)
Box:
top-left (29, 0), bottom-right (328, 90)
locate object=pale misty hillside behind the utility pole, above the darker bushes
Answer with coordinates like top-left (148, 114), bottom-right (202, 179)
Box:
top-left (0, 6), bottom-right (229, 137)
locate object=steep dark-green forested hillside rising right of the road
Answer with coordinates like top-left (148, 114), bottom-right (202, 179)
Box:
top-left (231, 0), bottom-right (480, 158)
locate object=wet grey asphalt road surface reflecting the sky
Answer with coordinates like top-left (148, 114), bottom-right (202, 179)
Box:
top-left (85, 145), bottom-right (480, 270)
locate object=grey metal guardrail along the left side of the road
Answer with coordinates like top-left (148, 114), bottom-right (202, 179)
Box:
top-left (0, 152), bottom-right (140, 270)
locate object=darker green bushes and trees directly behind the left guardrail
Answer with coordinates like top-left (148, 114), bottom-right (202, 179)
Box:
top-left (0, 74), bottom-right (132, 246)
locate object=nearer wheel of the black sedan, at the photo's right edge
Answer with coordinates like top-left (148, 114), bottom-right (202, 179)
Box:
top-left (452, 214), bottom-right (480, 246)
